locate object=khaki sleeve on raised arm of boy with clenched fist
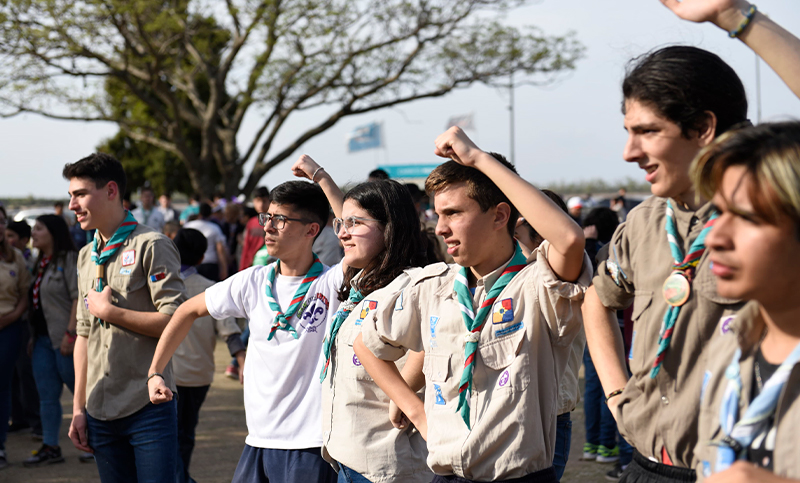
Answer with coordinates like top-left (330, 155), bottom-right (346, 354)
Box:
top-left (526, 240), bottom-right (592, 345)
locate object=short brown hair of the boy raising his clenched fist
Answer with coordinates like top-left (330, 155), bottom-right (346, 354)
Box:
top-left (425, 153), bottom-right (519, 238)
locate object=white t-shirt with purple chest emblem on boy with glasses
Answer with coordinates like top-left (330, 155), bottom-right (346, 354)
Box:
top-left (206, 264), bottom-right (344, 449)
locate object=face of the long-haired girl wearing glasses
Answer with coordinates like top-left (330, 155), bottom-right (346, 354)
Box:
top-left (336, 200), bottom-right (386, 269)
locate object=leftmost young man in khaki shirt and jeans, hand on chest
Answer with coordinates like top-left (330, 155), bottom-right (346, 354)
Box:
top-left (63, 153), bottom-right (185, 482)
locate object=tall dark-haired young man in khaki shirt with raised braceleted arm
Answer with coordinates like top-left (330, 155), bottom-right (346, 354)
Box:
top-left (584, 0), bottom-right (800, 482)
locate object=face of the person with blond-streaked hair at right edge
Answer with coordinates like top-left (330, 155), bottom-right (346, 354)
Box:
top-left (706, 166), bottom-right (800, 306)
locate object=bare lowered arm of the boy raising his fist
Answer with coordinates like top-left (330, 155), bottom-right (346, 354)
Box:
top-left (353, 334), bottom-right (425, 424)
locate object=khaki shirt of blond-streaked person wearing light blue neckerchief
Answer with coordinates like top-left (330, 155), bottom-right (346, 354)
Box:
top-left (695, 302), bottom-right (800, 481)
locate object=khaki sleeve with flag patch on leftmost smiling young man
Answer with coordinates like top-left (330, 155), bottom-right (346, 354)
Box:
top-left (142, 235), bottom-right (186, 315)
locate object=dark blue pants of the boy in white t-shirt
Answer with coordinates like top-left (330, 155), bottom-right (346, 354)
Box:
top-left (232, 445), bottom-right (336, 483)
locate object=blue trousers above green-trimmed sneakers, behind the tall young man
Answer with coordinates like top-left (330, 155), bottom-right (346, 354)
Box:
top-left (583, 348), bottom-right (617, 448)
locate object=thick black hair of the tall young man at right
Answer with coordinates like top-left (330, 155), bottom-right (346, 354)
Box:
top-left (622, 45), bottom-right (747, 137)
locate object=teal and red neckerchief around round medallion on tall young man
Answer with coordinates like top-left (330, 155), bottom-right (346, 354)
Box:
top-left (650, 200), bottom-right (718, 379)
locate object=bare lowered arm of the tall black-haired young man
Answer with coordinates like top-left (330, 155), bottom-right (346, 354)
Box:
top-left (582, 286), bottom-right (628, 400)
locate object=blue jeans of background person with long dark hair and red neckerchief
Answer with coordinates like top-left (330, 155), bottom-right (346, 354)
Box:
top-left (31, 336), bottom-right (75, 446)
